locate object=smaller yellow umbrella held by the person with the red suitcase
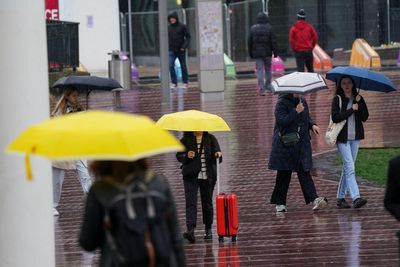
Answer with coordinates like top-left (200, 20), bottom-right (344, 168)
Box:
top-left (157, 110), bottom-right (231, 132)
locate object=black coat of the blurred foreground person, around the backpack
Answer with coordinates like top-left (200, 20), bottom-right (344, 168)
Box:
top-left (79, 176), bottom-right (186, 267)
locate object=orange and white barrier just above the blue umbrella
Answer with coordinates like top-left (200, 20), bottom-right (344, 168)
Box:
top-left (350, 38), bottom-right (381, 69)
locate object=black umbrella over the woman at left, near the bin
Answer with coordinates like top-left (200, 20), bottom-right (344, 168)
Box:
top-left (51, 75), bottom-right (122, 91)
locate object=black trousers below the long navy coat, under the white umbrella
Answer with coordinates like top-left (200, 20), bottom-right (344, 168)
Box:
top-left (271, 169), bottom-right (318, 205)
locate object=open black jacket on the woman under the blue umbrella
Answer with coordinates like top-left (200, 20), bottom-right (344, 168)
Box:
top-left (331, 95), bottom-right (369, 143)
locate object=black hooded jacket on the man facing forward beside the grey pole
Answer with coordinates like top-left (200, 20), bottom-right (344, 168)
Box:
top-left (168, 12), bottom-right (190, 52)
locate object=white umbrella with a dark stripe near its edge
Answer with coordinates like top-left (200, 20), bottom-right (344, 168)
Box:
top-left (271, 72), bottom-right (328, 94)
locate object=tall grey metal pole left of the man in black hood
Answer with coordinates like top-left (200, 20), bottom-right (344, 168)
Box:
top-left (158, 0), bottom-right (171, 103)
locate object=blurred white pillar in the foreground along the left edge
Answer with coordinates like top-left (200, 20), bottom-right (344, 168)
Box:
top-left (0, 0), bottom-right (55, 267)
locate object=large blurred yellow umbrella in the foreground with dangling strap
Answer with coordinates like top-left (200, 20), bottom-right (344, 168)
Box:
top-left (6, 111), bottom-right (184, 181)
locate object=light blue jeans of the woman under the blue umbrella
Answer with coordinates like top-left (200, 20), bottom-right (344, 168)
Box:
top-left (337, 140), bottom-right (360, 200)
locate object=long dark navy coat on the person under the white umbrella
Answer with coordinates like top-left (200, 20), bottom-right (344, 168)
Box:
top-left (268, 94), bottom-right (315, 171)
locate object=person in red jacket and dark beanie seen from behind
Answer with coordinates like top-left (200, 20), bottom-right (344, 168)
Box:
top-left (289, 9), bottom-right (318, 72)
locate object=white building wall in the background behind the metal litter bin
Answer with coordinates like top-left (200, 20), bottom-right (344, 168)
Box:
top-left (59, 0), bottom-right (120, 72)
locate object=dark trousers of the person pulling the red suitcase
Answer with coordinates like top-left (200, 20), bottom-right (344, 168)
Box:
top-left (183, 179), bottom-right (215, 230)
